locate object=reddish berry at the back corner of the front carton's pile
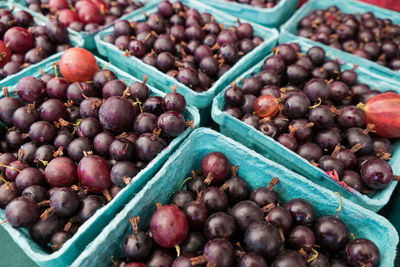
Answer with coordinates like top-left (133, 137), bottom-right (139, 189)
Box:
top-left (201, 152), bottom-right (230, 183)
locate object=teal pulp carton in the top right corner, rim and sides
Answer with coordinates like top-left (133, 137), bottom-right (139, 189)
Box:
top-left (279, 0), bottom-right (400, 81)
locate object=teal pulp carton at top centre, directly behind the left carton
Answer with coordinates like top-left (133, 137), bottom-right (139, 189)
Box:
top-left (95, 0), bottom-right (278, 125)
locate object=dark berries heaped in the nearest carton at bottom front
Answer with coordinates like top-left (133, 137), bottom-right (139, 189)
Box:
top-left (116, 152), bottom-right (381, 267)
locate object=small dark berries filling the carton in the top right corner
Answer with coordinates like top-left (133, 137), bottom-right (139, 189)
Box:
top-left (297, 6), bottom-right (400, 70)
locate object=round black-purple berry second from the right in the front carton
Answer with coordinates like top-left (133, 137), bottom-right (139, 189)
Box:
top-left (314, 215), bottom-right (350, 252)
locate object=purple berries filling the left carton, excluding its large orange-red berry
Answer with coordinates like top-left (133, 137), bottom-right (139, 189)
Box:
top-left (0, 66), bottom-right (187, 250)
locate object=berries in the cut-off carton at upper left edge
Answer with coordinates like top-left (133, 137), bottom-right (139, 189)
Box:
top-left (0, 9), bottom-right (70, 80)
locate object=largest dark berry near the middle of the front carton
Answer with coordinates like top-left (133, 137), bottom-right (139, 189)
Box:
top-left (244, 222), bottom-right (282, 259)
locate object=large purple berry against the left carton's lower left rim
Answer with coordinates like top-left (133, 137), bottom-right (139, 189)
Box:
top-left (5, 197), bottom-right (40, 228)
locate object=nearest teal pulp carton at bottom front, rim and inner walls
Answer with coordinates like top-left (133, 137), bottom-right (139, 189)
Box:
top-left (71, 128), bottom-right (398, 267)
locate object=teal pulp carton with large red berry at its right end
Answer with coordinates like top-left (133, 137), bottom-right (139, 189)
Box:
top-left (212, 41), bottom-right (400, 211)
